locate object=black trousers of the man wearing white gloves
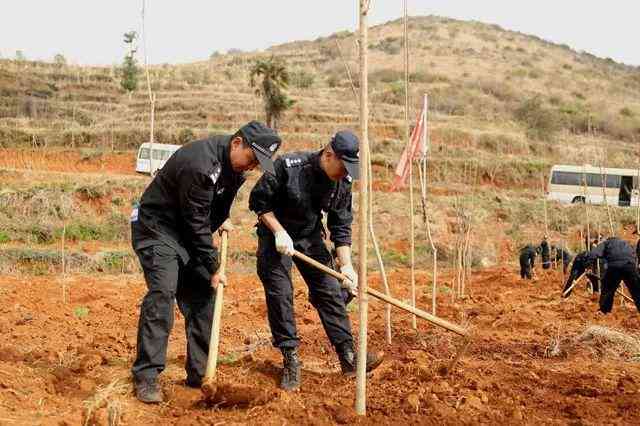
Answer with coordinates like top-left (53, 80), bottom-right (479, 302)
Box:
top-left (257, 233), bottom-right (353, 351)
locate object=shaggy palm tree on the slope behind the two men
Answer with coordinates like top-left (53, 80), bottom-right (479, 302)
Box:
top-left (249, 56), bottom-right (295, 129)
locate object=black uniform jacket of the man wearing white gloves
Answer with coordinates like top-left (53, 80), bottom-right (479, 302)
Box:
top-left (249, 151), bottom-right (353, 247)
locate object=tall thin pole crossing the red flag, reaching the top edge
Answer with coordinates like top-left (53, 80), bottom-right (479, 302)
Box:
top-left (403, 0), bottom-right (418, 330)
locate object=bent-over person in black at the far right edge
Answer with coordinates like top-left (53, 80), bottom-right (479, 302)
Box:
top-left (587, 237), bottom-right (640, 314)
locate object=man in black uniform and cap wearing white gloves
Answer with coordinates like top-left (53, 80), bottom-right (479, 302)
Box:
top-left (249, 131), bottom-right (382, 390)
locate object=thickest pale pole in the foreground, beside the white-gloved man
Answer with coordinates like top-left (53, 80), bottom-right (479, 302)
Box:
top-left (355, 0), bottom-right (370, 416)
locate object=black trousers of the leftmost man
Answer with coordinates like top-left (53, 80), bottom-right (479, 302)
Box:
top-left (131, 243), bottom-right (215, 381)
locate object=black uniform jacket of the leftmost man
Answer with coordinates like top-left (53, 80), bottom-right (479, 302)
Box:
top-left (132, 136), bottom-right (245, 279)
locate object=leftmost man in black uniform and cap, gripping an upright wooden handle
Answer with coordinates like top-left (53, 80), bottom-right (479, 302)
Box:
top-left (131, 121), bottom-right (281, 403)
